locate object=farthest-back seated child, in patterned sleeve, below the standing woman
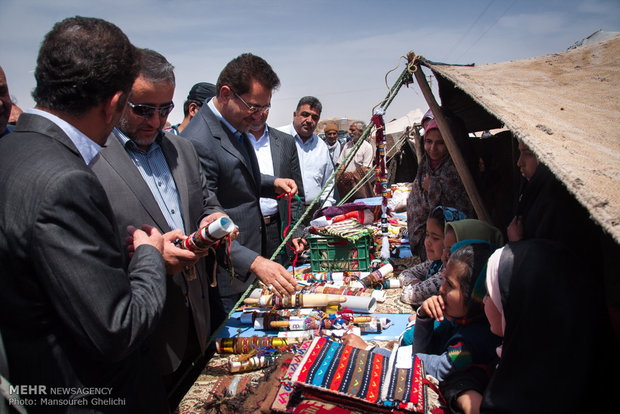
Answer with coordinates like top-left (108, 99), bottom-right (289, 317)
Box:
top-left (398, 206), bottom-right (466, 307)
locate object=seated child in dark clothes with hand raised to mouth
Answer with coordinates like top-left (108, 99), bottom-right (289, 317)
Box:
top-left (343, 240), bottom-right (500, 381)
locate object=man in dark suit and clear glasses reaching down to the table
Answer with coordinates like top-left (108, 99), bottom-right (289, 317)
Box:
top-left (181, 53), bottom-right (297, 313)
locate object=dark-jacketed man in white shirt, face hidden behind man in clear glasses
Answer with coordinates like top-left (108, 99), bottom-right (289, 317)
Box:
top-left (248, 105), bottom-right (305, 265)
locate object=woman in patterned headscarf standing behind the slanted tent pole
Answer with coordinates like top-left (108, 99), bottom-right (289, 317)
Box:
top-left (407, 110), bottom-right (474, 261)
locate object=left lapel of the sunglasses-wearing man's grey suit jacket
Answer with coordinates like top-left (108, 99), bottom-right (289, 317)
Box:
top-left (101, 134), bottom-right (170, 233)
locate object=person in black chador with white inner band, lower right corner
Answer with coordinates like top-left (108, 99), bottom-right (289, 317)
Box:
top-left (480, 240), bottom-right (618, 413)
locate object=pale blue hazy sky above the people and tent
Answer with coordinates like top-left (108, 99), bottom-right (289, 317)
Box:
top-left (0, 0), bottom-right (620, 126)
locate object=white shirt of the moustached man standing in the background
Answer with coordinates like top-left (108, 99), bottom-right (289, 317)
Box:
top-left (278, 124), bottom-right (336, 207)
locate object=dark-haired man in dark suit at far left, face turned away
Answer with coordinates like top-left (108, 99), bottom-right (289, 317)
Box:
top-left (0, 17), bottom-right (167, 413)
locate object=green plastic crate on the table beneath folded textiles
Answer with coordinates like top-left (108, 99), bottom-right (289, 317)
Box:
top-left (309, 235), bottom-right (371, 272)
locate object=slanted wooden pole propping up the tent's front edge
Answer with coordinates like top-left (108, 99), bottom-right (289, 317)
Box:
top-left (414, 61), bottom-right (491, 223)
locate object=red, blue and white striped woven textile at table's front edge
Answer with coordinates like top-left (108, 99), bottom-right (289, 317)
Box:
top-left (292, 338), bottom-right (426, 412)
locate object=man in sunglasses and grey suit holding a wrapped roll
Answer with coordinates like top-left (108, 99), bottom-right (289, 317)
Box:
top-left (93, 49), bottom-right (225, 409)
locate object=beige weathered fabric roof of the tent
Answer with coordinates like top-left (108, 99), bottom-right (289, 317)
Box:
top-left (422, 36), bottom-right (620, 243)
